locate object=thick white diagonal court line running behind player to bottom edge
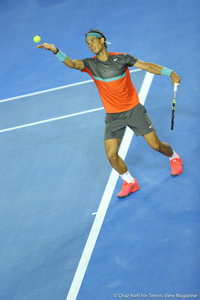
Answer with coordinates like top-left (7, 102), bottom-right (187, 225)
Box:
top-left (66, 73), bottom-right (154, 300)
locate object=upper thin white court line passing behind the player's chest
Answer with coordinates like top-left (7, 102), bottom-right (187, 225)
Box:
top-left (0, 69), bottom-right (142, 103)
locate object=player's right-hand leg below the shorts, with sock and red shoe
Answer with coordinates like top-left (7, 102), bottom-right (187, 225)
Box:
top-left (144, 130), bottom-right (183, 176)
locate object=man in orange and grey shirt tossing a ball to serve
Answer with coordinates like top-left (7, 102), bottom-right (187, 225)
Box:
top-left (37, 30), bottom-right (183, 198)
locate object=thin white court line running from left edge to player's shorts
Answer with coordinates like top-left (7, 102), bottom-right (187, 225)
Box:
top-left (0, 107), bottom-right (104, 133)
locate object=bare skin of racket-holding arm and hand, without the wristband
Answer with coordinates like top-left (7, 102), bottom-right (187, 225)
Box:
top-left (134, 60), bottom-right (181, 84)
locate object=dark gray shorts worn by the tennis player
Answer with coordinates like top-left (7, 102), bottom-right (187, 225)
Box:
top-left (104, 103), bottom-right (155, 140)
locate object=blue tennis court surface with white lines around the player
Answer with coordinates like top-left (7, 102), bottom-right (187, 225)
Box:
top-left (0, 0), bottom-right (200, 300)
